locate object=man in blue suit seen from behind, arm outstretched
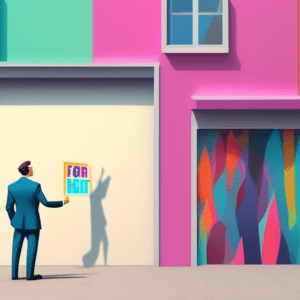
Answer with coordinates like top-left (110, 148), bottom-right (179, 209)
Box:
top-left (6, 161), bottom-right (69, 280)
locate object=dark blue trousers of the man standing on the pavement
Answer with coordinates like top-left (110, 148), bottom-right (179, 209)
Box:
top-left (12, 229), bottom-right (40, 279)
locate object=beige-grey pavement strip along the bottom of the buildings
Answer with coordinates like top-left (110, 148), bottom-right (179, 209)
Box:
top-left (0, 265), bottom-right (300, 300)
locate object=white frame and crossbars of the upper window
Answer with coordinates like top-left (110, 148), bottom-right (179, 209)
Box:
top-left (162, 0), bottom-right (229, 53)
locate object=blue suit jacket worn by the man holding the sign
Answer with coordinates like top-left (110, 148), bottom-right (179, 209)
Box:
top-left (6, 177), bottom-right (63, 230)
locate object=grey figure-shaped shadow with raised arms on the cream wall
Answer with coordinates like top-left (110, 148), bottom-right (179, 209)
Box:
top-left (82, 168), bottom-right (111, 267)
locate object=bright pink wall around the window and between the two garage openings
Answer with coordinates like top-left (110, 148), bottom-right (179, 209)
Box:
top-left (93, 0), bottom-right (298, 266)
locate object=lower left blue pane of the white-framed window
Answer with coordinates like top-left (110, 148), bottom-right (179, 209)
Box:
top-left (168, 15), bottom-right (193, 45)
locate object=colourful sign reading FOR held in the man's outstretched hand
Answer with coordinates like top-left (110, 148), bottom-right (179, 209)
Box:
top-left (64, 162), bottom-right (92, 196)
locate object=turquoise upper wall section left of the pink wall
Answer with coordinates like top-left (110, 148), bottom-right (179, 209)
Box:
top-left (0, 0), bottom-right (93, 63)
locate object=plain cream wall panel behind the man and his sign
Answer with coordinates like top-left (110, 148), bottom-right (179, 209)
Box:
top-left (0, 105), bottom-right (154, 265)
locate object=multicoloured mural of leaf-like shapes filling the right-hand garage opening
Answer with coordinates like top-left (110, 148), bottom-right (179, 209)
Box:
top-left (197, 129), bottom-right (300, 265)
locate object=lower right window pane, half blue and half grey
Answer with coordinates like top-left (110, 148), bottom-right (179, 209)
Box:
top-left (199, 16), bottom-right (223, 45)
